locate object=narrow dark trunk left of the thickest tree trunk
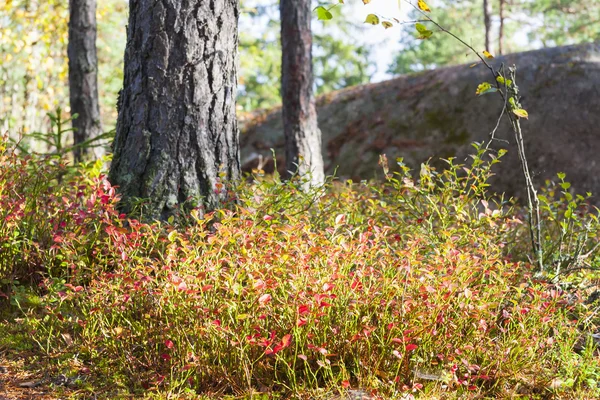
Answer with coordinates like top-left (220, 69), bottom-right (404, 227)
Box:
top-left (67, 0), bottom-right (102, 161)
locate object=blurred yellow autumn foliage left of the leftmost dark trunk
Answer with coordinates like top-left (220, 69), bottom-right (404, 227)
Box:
top-left (0, 0), bottom-right (69, 136)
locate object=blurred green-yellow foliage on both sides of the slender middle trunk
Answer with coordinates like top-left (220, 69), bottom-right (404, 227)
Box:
top-left (238, 0), bottom-right (375, 112)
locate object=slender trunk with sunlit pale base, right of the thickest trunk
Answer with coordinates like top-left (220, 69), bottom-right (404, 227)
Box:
top-left (279, 0), bottom-right (325, 186)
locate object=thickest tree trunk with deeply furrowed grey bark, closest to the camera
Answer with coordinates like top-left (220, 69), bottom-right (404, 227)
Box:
top-left (109, 0), bottom-right (240, 219)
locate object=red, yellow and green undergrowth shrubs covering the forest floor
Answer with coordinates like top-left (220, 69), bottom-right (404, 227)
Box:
top-left (0, 139), bottom-right (600, 398)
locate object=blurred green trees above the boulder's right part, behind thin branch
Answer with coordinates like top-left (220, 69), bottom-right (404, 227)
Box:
top-left (388, 0), bottom-right (600, 74)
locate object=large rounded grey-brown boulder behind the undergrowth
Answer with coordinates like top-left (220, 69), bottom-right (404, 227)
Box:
top-left (240, 43), bottom-right (600, 200)
